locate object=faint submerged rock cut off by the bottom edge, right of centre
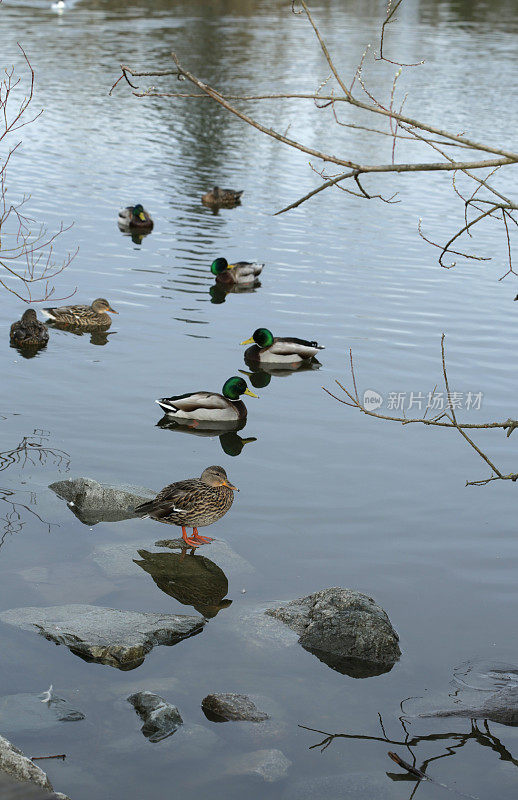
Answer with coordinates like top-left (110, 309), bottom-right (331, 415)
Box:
top-left (281, 772), bottom-right (396, 800)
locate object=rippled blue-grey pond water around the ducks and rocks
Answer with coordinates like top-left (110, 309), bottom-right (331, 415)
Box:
top-left (0, 0), bottom-right (518, 800)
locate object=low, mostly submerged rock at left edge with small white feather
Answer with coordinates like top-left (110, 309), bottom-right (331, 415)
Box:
top-left (0, 693), bottom-right (85, 734)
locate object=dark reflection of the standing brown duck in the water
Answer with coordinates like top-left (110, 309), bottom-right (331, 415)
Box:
top-left (134, 542), bottom-right (232, 619)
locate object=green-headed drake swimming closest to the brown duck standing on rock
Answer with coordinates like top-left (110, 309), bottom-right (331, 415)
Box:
top-left (155, 375), bottom-right (257, 428)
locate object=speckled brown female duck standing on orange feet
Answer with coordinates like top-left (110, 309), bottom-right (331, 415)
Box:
top-left (135, 466), bottom-right (239, 547)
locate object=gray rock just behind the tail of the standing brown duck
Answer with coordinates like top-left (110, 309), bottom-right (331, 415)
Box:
top-left (49, 478), bottom-right (156, 525)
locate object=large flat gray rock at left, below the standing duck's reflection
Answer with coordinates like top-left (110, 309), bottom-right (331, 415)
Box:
top-left (0, 604), bottom-right (205, 670)
